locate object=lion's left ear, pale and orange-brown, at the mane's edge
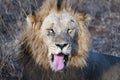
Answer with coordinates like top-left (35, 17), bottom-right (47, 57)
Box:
top-left (26, 13), bottom-right (38, 26)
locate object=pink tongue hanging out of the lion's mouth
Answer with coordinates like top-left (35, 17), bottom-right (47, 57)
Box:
top-left (52, 55), bottom-right (64, 71)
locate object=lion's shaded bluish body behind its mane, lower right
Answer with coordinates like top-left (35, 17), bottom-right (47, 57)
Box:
top-left (84, 52), bottom-right (120, 80)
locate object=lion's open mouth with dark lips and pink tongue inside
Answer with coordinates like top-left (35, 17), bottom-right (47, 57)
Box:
top-left (51, 53), bottom-right (68, 71)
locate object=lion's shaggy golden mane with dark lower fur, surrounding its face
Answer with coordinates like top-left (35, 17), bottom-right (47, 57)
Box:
top-left (19, 0), bottom-right (91, 80)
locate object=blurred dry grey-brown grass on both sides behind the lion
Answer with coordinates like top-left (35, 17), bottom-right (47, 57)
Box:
top-left (0, 0), bottom-right (120, 80)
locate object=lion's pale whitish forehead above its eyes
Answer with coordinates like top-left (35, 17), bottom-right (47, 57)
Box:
top-left (42, 12), bottom-right (77, 28)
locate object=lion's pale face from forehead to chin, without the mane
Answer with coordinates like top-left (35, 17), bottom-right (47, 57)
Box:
top-left (41, 12), bottom-right (78, 71)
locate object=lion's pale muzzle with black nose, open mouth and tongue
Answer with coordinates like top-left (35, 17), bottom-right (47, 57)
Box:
top-left (49, 36), bottom-right (71, 71)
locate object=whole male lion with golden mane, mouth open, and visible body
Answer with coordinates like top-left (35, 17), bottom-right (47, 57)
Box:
top-left (19, 0), bottom-right (120, 80)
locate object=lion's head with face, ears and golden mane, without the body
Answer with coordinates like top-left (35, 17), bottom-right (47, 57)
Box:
top-left (21, 0), bottom-right (91, 71)
